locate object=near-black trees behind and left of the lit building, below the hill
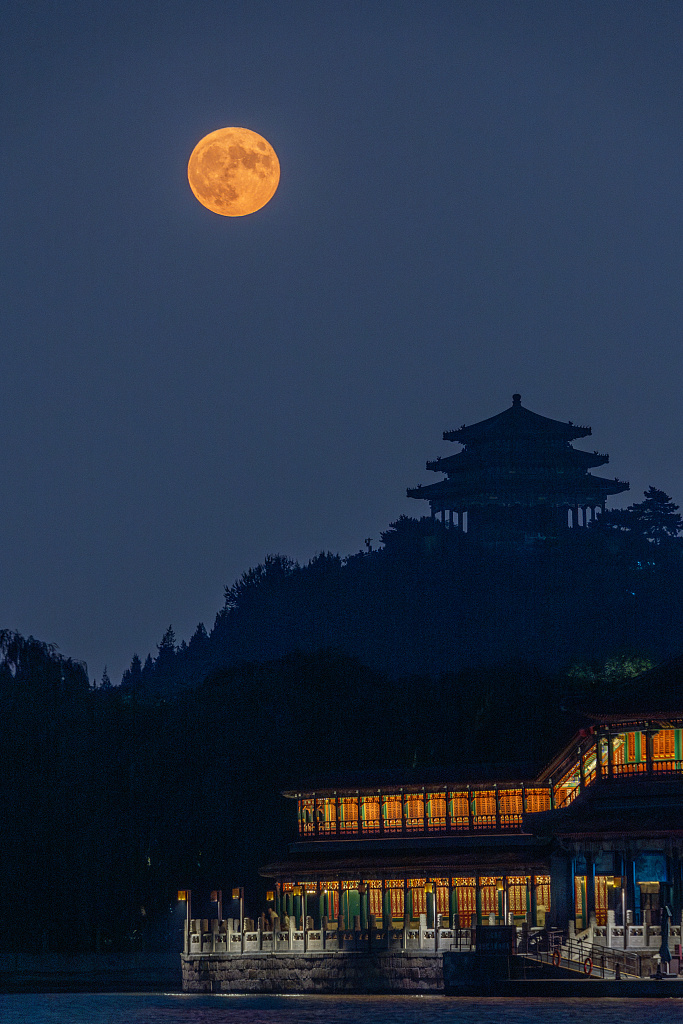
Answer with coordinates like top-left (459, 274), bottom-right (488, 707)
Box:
top-left (0, 633), bottom-right (663, 951)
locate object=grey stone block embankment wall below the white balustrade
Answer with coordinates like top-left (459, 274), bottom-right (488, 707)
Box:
top-left (181, 950), bottom-right (443, 993)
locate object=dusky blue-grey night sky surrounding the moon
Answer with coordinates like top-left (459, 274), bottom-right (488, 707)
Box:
top-left (0, 0), bottom-right (683, 681)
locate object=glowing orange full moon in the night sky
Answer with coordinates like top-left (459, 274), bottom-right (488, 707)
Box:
top-left (187, 128), bottom-right (280, 217)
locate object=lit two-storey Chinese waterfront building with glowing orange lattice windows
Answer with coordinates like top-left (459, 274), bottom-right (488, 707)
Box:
top-left (262, 713), bottom-right (683, 946)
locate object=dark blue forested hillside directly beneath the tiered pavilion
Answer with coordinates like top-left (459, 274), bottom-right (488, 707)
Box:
top-left (123, 507), bottom-right (683, 690)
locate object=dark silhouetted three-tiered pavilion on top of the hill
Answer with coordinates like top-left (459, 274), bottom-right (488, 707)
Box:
top-left (408, 394), bottom-right (629, 543)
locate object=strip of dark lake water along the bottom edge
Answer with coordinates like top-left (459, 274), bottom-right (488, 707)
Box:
top-left (0, 993), bottom-right (683, 1024)
